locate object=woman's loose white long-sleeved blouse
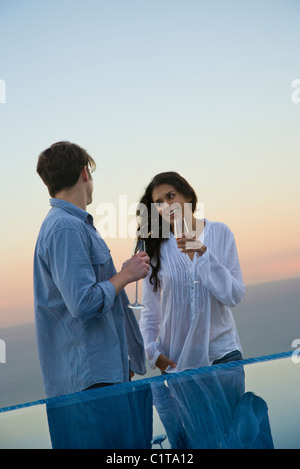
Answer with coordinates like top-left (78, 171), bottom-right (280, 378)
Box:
top-left (139, 220), bottom-right (245, 372)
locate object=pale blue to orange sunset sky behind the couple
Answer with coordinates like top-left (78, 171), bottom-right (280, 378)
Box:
top-left (0, 0), bottom-right (300, 327)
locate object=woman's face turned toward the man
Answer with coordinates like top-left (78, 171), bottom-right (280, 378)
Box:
top-left (152, 184), bottom-right (192, 225)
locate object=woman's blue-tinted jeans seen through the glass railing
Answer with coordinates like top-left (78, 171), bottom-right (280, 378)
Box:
top-left (151, 365), bottom-right (274, 449)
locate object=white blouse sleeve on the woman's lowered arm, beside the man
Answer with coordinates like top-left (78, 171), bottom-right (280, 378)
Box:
top-left (139, 268), bottom-right (161, 368)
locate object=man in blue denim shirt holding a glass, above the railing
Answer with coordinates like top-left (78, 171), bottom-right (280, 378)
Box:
top-left (34, 142), bottom-right (149, 397)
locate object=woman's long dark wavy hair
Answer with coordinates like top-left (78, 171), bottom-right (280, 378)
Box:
top-left (137, 171), bottom-right (198, 291)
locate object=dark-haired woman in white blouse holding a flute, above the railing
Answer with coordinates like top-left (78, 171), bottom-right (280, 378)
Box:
top-left (139, 172), bottom-right (245, 372)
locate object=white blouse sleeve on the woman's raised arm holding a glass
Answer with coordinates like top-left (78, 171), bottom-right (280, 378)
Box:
top-left (197, 227), bottom-right (245, 307)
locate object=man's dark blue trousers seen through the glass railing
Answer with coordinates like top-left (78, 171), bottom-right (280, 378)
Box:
top-left (47, 385), bottom-right (153, 449)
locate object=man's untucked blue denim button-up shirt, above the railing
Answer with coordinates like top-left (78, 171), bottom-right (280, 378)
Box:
top-left (34, 199), bottom-right (146, 397)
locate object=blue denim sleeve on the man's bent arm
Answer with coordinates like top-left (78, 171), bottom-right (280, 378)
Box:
top-left (48, 228), bottom-right (115, 320)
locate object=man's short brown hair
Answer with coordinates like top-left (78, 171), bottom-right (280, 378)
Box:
top-left (36, 141), bottom-right (96, 197)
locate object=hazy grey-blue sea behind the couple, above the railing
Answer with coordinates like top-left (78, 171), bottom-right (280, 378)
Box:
top-left (0, 278), bottom-right (300, 408)
